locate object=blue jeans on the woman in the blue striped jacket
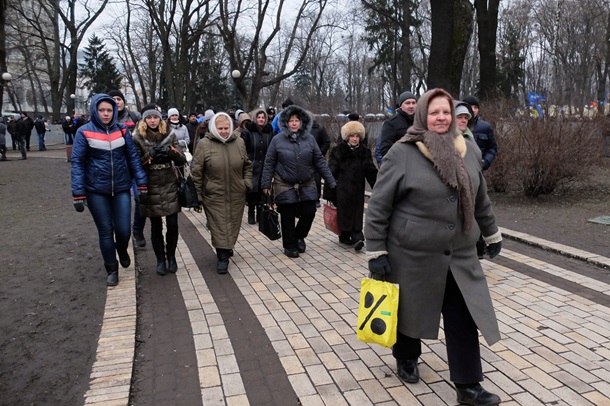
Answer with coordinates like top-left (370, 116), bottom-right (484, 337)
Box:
top-left (87, 190), bottom-right (131, 265)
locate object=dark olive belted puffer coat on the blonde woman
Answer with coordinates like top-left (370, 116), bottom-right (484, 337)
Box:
top-left (133, 121), bottom-right (186, 217)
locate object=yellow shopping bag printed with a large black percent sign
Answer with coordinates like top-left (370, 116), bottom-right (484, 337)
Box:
top-left (356, 278), bottom-right (398, 348)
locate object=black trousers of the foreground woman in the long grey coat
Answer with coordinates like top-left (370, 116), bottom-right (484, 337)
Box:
top-left (392, 271), bottom-right (483, 384)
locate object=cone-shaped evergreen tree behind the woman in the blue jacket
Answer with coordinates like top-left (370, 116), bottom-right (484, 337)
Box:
top-left (80, 34), bottom-right (122, 97)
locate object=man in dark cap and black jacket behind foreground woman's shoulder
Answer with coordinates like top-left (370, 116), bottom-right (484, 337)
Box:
top-left (375, 92), bottom-right (417, 166)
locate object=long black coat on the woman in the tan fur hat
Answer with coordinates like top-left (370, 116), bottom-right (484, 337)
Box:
top-left (325, 141), bottom-right (377, 232)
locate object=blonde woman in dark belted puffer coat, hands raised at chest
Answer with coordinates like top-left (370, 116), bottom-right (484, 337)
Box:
top-left (133, 104), bottom-right (186, 275)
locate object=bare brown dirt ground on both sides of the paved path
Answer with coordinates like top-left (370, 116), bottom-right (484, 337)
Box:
top-left (0, 146), bottom-right (610, 405)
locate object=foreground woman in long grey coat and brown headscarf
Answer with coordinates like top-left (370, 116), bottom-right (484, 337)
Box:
top-left (365, 89), bottom-right (502, 405)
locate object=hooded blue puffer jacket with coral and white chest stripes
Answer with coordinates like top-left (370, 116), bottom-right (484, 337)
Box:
top-left (71, 93), bottom-right (147, 196)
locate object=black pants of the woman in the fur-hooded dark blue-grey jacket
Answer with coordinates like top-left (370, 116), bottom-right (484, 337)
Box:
top-left (277, 200), bottom-right (316, 250)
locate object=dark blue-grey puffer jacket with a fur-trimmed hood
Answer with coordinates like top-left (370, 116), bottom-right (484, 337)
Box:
top-left (261, 105), bottom-right (336, 204)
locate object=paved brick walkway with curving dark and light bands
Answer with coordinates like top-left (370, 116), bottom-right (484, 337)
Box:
top-left (84, 198), bottom-right (610, 406)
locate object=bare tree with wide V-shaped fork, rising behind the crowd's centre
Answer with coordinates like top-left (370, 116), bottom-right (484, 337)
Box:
top-left (218, 0), bottom-right (327, 109)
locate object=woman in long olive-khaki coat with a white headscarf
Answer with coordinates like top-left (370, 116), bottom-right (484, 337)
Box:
top-left (191, 113), bottom-right (252, 274)
